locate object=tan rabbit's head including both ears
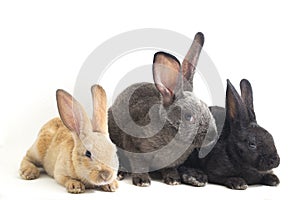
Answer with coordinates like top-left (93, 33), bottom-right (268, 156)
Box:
top-left (56, 85), bottom-right (118, 185)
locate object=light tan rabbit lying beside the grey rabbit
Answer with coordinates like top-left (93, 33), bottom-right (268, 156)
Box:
top-left (20, 85), bottom-right (119, 193)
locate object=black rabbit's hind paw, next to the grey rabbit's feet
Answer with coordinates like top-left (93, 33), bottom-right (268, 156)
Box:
top-left (181, 171), bottom-right (208, 187)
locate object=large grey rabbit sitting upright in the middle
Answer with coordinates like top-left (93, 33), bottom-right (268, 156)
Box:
top-left (108, 32), bottom-right (218, 187)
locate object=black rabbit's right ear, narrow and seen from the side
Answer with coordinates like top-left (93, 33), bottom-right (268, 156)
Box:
top-left (240, 79), bottom-right (256, 122)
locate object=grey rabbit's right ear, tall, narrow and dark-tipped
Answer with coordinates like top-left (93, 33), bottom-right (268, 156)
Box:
top-left (182, 32), bottom-right (204, 91)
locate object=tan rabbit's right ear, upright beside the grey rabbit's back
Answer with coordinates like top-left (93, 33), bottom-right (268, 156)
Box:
top-left (91, 85), bottom-right (108, 133)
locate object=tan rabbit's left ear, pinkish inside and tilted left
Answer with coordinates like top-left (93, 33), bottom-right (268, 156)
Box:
top-left (56, 90), bottom-right (92, 138)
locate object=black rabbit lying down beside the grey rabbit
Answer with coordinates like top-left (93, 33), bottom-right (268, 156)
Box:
top-left (179, 79), bottom-right (280, 190)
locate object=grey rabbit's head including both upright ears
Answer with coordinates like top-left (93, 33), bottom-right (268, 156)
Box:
top-left (153, 33), bottom-right (218, 147)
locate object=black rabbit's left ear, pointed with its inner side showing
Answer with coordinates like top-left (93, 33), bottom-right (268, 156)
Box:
top-left (226, 80), bottom-right (249, 128)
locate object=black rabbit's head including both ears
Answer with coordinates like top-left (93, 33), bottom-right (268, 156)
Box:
top-left (226, 79), bottom-right (280, 171)
